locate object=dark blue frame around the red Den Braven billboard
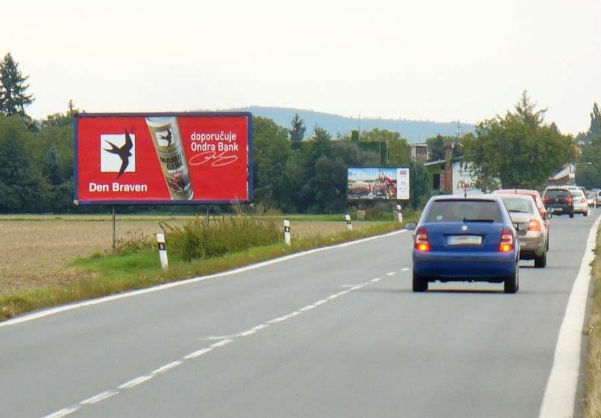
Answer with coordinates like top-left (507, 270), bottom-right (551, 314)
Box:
top-left (73, 112), bottom-right (254, 206)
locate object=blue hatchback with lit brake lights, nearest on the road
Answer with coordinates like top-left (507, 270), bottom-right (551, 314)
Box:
top-left (407, 195), bottom-right (520, 293)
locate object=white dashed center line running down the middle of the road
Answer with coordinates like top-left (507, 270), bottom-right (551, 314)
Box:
top-left (44, 268), bottom-right (409, 418)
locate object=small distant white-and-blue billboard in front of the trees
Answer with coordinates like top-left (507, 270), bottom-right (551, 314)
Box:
top-left (347, 167), bottom-right (409, 200)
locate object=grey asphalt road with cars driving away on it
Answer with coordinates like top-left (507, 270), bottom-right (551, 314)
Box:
top-left (0, 211), bottom-right (601, 418)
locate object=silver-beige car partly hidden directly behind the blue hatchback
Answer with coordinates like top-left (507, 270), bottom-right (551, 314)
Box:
top-left (499, 194), bottom-right (548, 268)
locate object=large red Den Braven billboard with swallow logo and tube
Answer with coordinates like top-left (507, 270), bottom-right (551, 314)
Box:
top-left (73, 112), bottom-right (252, 205)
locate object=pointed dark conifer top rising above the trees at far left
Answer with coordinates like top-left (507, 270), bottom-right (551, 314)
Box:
top-left (0, 53), bottom-right (34, 116)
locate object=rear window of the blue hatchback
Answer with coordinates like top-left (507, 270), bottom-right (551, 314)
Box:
top-left (426, 199), bottom-right (502, 222)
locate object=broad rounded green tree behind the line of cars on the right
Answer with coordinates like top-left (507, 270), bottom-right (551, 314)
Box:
top-left (463, 92), bottom-right (576, 189)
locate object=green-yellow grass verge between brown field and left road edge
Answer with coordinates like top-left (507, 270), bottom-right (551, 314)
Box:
top-left (0, 219), bottom-right (413, 321)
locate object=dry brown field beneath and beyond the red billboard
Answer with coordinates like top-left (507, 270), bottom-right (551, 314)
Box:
top-left (0, 216), bottom-right (376, 295)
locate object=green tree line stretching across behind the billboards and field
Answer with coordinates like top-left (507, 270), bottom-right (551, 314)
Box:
top-left (0, 54), bottom-right (601, 213)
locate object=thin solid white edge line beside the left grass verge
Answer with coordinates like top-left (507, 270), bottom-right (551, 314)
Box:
top-left (0, 229), bottom-right (407, 328)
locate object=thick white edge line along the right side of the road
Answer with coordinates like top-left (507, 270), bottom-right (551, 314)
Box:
top-left (539, 217), bottom-right (601, 418)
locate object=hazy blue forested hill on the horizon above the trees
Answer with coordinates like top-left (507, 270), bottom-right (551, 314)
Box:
top-left (229, 106), bottom-right (474, 143)
